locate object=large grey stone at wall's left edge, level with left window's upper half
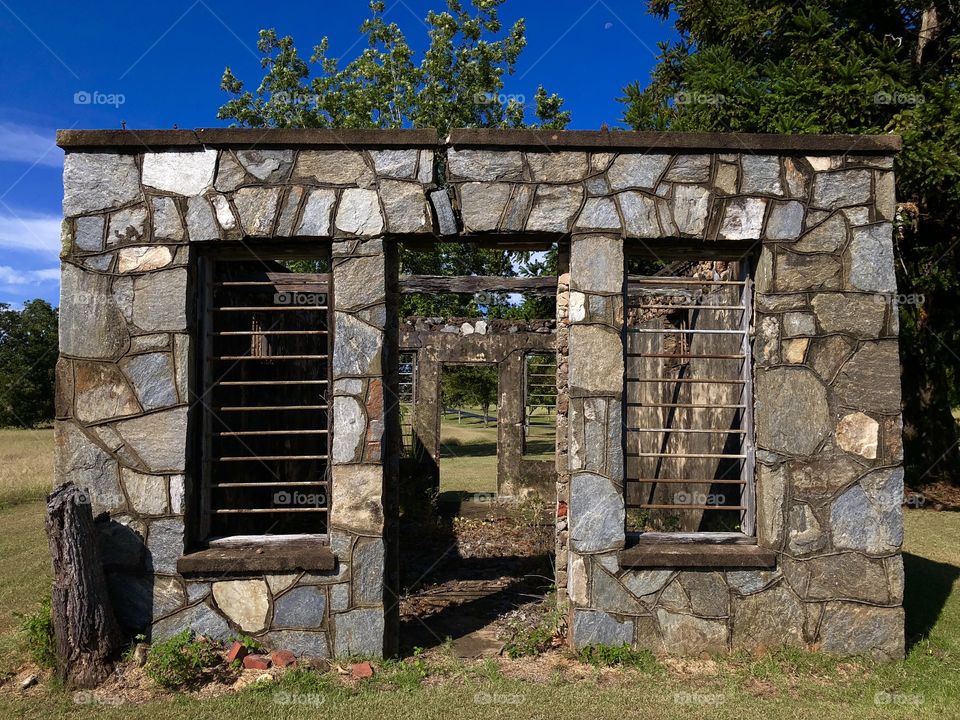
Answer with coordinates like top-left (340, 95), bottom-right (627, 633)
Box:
top-left (60, 263), bottom-right (128, 358)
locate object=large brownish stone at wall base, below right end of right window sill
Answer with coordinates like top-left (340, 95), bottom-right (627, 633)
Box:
top-left (731, 584), bottom-right (805, 650)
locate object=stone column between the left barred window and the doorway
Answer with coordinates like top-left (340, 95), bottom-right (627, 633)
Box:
top-left (330, 238), bottom-right (393, 657)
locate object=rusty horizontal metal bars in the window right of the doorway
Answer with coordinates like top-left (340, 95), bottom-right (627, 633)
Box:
top-left (624, 268), bottom-right (755, 535)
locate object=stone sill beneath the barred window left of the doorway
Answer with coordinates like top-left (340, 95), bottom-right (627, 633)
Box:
top-left (177, 538), bottom-right (337, 575)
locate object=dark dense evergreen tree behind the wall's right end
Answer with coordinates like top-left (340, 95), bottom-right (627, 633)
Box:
top-left (622, 0), bottom-right (960, 482)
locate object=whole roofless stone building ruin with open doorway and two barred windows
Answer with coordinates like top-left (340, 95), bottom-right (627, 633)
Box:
top-left (56, 129), bottom-right (904, 658)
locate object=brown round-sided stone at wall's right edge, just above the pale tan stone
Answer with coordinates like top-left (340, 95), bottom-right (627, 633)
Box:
top-left (834, 341), bottom-right (900, 413)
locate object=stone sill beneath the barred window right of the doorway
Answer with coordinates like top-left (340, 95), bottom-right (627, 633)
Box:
top-left (619, 536), bottom-right (777, 568)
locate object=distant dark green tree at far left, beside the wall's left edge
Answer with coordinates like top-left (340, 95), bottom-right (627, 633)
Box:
top-left (0, 300), bottom-right (57, 427)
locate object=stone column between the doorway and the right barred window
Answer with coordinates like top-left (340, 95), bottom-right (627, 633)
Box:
top-left (567, 234), bottom-right (634, 647)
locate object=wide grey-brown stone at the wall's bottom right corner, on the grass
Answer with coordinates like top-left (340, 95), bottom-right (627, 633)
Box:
top-left (820, 602), bottom-right (905, 660)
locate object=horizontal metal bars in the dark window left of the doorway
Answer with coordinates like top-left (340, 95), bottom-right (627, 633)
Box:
top-left (200, 257), bottom-right (333, 537)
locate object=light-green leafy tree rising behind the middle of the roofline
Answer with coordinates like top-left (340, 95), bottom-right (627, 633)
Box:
top-left (217, 0), bottom-right (570, 316)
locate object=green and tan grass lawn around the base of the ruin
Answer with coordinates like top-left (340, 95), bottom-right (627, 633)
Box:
top-left (0, 430), bottom-right (960, 720)
